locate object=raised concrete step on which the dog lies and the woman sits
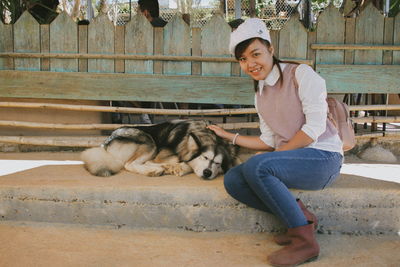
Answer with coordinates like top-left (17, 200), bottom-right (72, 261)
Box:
top-left (0, 153), bottom-right (400, 235)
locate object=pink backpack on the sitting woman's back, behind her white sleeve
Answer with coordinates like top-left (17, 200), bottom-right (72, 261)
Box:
top-left (326, 97), bottom-right (356, 151)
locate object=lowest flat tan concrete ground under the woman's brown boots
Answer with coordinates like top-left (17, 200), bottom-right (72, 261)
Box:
top-left (0, 222), bottom-right (400, 267)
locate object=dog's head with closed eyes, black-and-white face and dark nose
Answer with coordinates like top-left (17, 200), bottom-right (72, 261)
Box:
top-left (185, 129), bottom-right (237, 180)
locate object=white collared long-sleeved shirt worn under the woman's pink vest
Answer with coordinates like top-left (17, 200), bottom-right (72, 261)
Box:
top-left (254, 63), bottom-right (343, 153)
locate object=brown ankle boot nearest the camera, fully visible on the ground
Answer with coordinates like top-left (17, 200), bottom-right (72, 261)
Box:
top-left (268, 222), bottom-right (319, 267)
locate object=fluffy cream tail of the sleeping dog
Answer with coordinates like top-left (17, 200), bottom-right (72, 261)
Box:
top-left (81, 147), bottom-right (124, 177)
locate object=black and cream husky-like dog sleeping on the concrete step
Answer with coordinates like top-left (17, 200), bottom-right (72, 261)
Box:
top-left (81, 120), bottom-right (239, 180)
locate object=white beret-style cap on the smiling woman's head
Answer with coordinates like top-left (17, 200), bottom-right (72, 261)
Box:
top-left (229, 18), bottom-right (271, 55)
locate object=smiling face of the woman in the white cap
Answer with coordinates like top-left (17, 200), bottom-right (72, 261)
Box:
top-left (239, 39), bottom-right (274, 81)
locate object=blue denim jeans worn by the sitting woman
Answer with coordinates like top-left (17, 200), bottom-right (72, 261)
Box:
top-left (224, 148), bottom-right (343, 228)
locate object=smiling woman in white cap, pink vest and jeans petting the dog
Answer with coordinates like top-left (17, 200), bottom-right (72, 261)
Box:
top-left (209, 18), bottom-right (343, 266)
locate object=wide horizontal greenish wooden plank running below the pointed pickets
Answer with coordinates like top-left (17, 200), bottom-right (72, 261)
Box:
top-left (0, 65), bottom-right (400, 105)
